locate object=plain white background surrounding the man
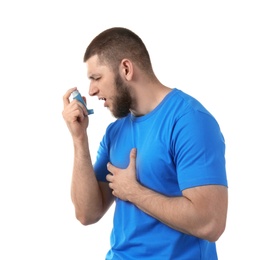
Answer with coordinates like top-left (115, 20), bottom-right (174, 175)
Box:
top-left (0, 0), bottom-right (262, 260)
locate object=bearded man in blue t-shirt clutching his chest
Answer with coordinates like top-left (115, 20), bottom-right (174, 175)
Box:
top-left (63, 27), bottom-right (228, 260)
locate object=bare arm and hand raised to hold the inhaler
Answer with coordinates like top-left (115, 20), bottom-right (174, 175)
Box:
top-left (63, 88), bottom-right (113, 225)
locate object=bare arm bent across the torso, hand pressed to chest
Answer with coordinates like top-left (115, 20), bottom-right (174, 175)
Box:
top-left (107, 150), bottom-right (228, 241)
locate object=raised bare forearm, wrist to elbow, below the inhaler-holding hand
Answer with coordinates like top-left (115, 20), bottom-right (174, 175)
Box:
top-left (71, 136), bottom-right (103, 225)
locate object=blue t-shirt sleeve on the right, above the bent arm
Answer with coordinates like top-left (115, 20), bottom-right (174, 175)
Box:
top-left (174, 111), bottom-right (227, 190)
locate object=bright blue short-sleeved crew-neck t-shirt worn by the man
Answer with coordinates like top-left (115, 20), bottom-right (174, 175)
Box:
top-left (94, 89), bottom-right (227, 260)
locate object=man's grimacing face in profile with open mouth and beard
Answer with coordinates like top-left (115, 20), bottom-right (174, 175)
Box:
top-left (87, 56), bottom-right (132, 118)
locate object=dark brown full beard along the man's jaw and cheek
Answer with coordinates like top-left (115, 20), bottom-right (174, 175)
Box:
top-left (111, 74), bottom-right (133, 118)
